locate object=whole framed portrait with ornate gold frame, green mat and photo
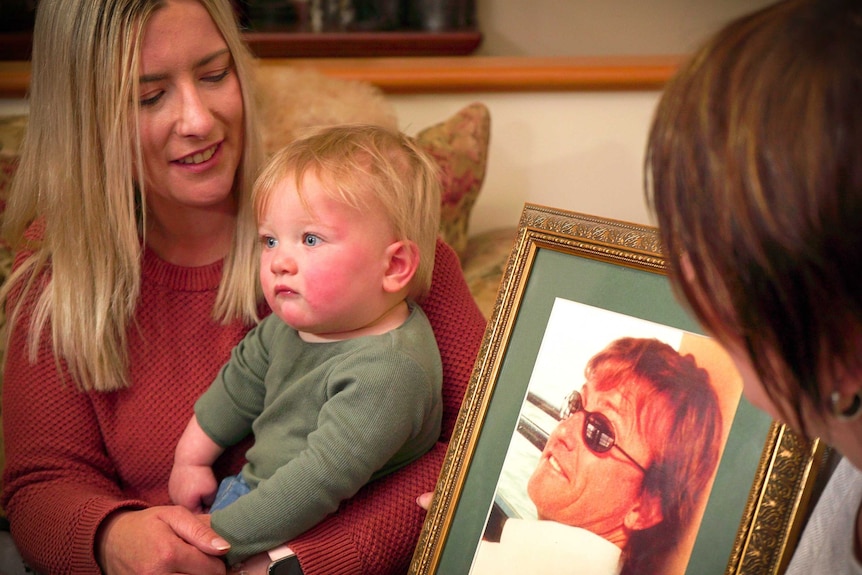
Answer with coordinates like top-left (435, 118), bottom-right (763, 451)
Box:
top-left (410, 204), bottom-right (825, 575)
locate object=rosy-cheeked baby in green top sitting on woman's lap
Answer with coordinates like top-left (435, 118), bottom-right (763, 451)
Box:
top-left (169, 125), bottom-right (442, 563)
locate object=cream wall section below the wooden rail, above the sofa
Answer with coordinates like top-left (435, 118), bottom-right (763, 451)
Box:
top-left (390, 92), bottom-right (659, 233)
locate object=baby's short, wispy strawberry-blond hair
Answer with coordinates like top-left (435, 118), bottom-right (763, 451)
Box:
top-left (252, 124), bottom-right (440, 300)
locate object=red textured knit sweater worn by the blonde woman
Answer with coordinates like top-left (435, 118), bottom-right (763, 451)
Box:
top-left (3, 238), bottom-right (485, 575)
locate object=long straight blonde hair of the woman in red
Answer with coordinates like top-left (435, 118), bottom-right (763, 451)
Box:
top-left (2, 0), bottom-right (261, 391)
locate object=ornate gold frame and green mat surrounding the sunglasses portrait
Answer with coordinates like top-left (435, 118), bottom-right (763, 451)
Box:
top-left (410, 204), bottom-right (825, 575)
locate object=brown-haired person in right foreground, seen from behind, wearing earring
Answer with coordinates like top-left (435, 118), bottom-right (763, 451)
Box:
top-left (646, 0), bottom-right (862, 574)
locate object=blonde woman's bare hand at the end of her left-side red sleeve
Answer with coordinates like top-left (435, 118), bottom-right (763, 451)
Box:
top-left (96, 506), bottom-right (230, 575)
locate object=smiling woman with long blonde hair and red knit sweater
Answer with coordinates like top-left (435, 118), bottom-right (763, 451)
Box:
top-left (2, 0), bottom-right (483, 574)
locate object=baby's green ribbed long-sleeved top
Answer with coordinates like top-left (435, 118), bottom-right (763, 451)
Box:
top-left (195, 305), bottom-right (442, 562)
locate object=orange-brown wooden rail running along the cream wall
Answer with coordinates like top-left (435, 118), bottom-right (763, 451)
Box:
top-left (0, 56), bottom-right (681, 98)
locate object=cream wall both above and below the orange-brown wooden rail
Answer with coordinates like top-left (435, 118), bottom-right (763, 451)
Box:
top-left (391, 0), bottom-right (774, 232)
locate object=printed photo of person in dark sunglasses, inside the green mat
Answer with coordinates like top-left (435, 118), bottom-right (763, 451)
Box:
top-left (470, 300), bottom-right (741, 575)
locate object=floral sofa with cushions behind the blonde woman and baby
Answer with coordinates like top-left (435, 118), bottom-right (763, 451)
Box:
top-left (0, 66), bottom-right (516, 512)
